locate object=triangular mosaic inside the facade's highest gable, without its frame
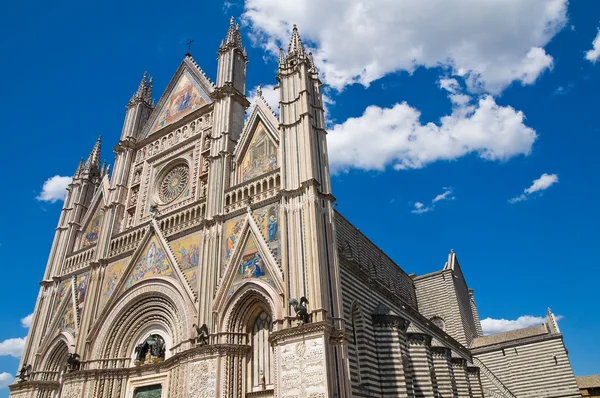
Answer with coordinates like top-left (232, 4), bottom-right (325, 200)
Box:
top-left (150, 71), bottom-right (207, 134)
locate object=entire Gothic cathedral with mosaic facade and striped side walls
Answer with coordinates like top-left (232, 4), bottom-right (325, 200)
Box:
top-left (10, 19), bottom-right (580, 398)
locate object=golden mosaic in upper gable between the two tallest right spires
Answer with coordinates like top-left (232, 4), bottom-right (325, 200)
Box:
top-left (241, 122), bottom-right (277, 181)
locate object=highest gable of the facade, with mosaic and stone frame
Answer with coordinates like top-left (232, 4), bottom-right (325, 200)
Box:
top-left (143, 57), bottom-right (213, 137)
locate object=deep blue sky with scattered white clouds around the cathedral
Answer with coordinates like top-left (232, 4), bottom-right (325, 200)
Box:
top-left (0, 0), bottom-right (600, 397)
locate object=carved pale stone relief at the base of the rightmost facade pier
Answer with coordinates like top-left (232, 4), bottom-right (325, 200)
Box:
top-left (277, 337), bottom-right (327, 398)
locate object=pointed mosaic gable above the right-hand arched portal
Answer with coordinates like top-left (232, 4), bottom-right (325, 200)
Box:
top-left (215, 215), bottom-right (284, 312)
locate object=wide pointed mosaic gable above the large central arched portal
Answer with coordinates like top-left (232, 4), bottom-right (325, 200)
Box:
top-left (94, 220), bottom-right (196, 329)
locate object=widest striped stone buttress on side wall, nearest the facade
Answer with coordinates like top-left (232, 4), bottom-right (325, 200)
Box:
top-left (373, 310), bottom-right (413, 398)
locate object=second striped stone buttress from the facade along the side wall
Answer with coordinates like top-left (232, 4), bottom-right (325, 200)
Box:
top-left (407, 333), bottom-right (439, 398)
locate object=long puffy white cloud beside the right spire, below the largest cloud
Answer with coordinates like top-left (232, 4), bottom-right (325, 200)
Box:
top-left (327, 91), bottom-right (537, 172)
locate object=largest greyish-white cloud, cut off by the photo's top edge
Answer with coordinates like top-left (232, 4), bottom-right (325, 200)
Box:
top-left (242, 0), bottom-right (568, 94)
